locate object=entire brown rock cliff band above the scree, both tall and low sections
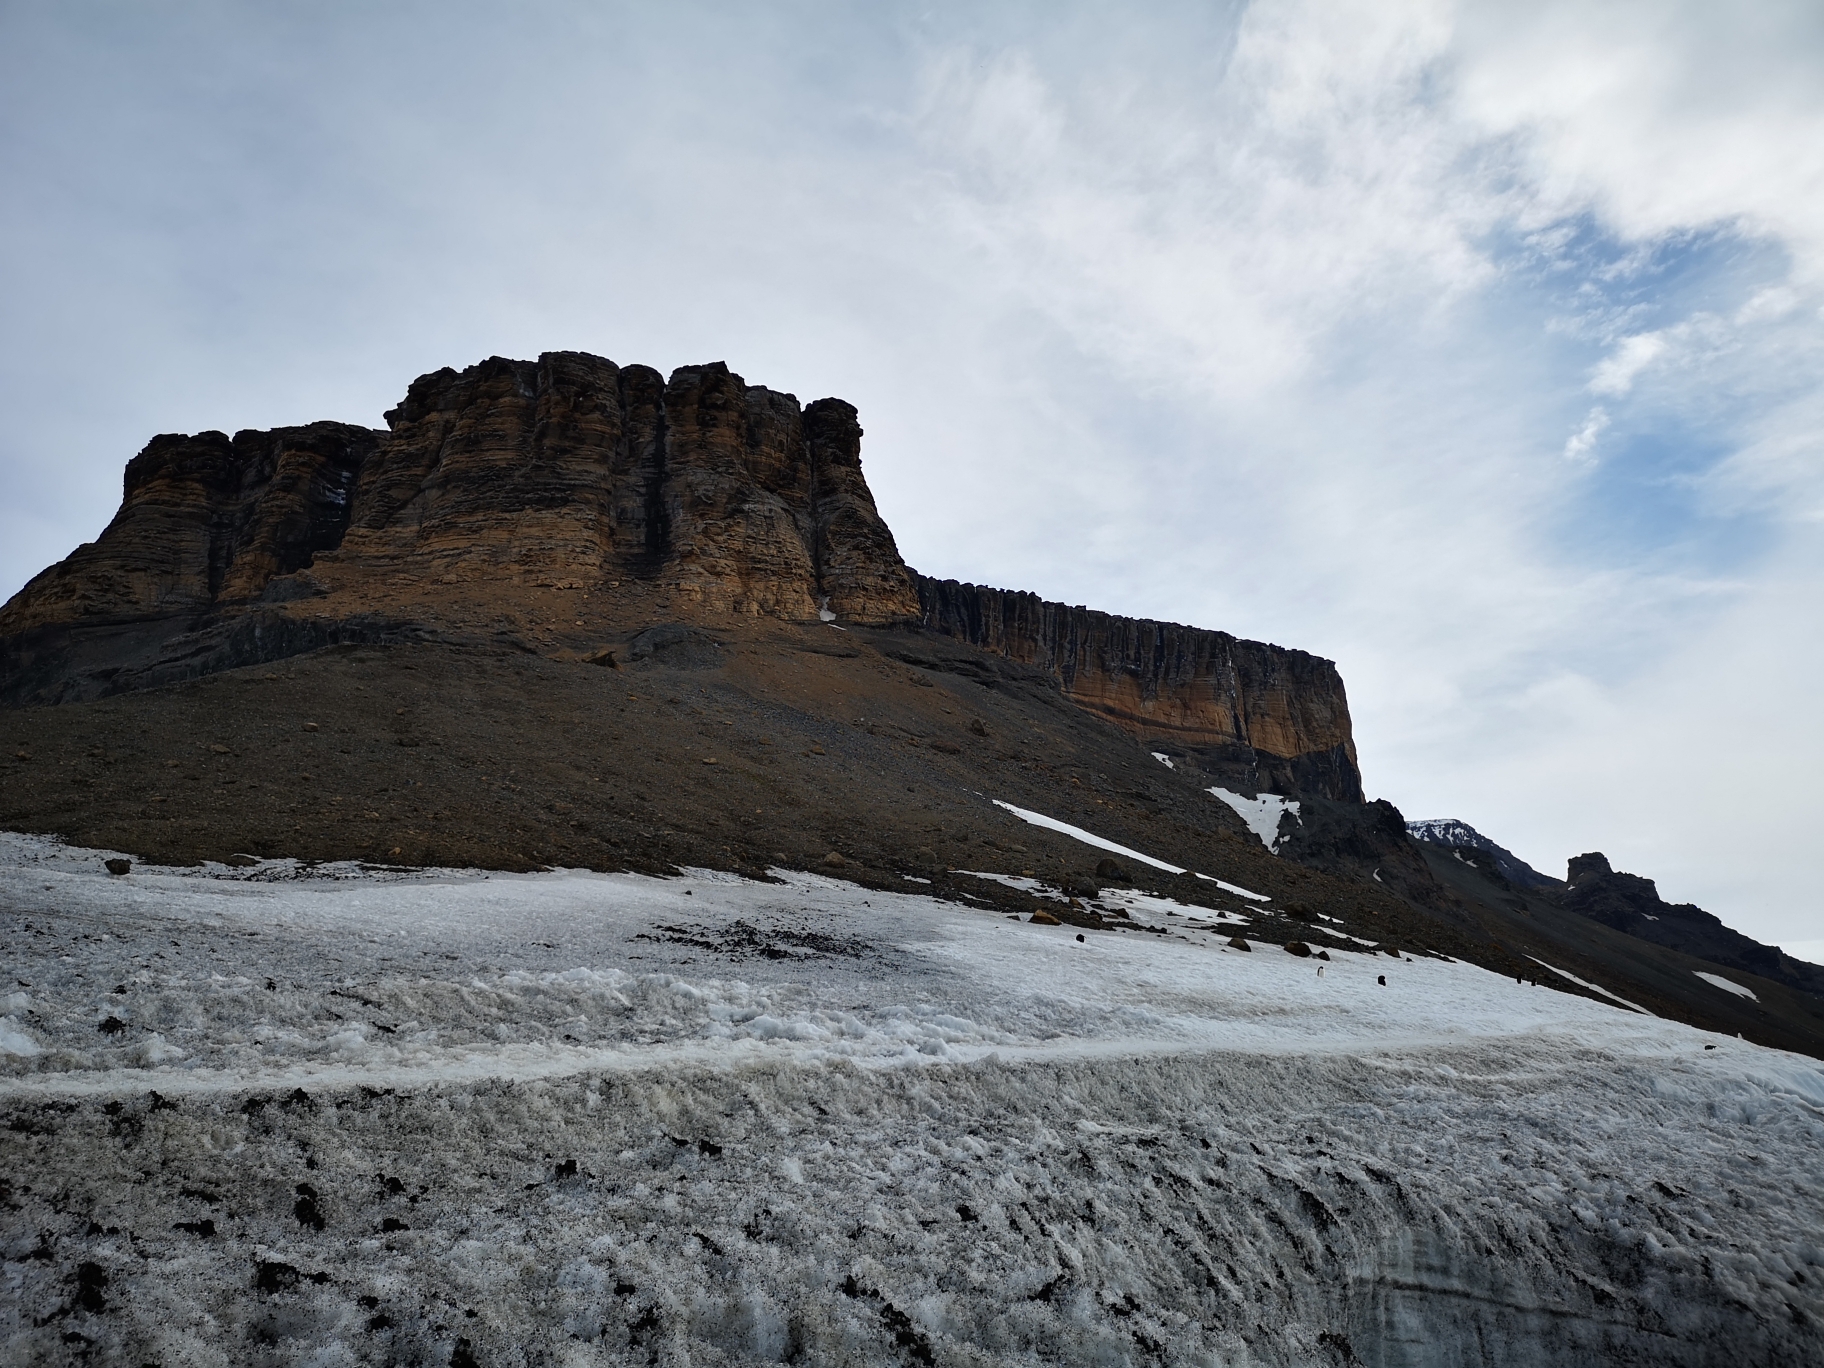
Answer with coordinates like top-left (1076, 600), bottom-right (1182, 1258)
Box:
top-left (0, 352), bottom-right (1361, 803)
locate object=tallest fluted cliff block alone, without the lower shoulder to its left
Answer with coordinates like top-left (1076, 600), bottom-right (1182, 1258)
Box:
top-left (316, 352), bottom-right (917, 622)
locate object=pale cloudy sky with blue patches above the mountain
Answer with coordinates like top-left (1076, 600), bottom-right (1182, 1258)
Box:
top-left (0, 0), bottom-right (1824, 958)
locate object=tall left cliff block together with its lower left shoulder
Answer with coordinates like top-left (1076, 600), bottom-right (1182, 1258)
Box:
top-left (0, 352), bottom-right (917, 704)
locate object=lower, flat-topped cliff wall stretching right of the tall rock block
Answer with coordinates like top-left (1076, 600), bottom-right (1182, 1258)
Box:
top-left (916, 575), bottom-right (1363, 803)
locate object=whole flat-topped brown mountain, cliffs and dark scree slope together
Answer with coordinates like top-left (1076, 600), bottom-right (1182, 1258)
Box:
top-left (0, 352), bottom-right (1824, 1052)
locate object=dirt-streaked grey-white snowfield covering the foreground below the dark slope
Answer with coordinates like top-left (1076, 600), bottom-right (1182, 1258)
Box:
top-left (0, 837), bottom-right (1824, 1364)
